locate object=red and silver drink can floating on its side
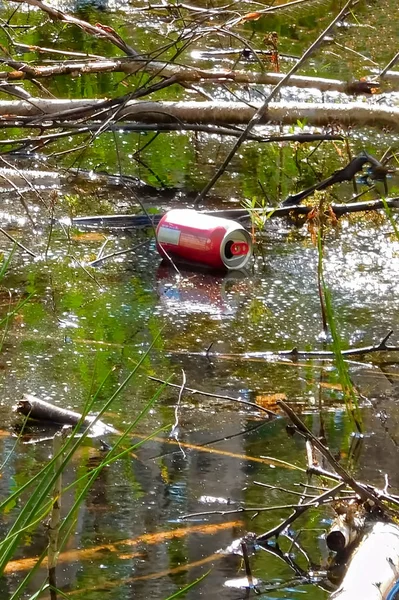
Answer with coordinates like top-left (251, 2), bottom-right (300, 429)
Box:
top-left (157, 209), bottom-right (252, 269)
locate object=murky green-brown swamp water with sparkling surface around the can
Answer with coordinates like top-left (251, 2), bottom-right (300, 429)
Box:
top-left (0, 2), bottom-right (399, 600)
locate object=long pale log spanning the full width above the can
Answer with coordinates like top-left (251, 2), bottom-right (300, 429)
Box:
top-left (0, 98), bottom-right (399, 129)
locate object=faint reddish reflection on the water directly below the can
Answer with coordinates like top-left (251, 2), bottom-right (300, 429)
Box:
top-left (157, 263), bottom-right (250, 316)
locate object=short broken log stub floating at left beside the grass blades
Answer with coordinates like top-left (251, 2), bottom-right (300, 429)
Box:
top-left (14, 394), bottom-right (118, 433)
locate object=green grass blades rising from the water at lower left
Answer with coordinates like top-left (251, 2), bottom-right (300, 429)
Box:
top-left (0, 248), bottom-right (170, 600)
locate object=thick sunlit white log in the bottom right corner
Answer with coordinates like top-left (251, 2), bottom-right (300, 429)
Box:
top-left (330, 521), bottom-right (399, 600)
